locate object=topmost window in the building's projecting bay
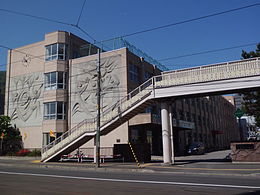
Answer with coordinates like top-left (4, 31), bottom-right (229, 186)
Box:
top-left (45, 43), bottom-right (67, 61)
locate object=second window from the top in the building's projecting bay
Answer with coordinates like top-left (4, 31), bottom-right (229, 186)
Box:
top-left (44, 72), bottom-right (67, 90)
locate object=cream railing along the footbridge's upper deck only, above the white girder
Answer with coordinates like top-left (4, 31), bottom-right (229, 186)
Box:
top-left (154, 58), bottom-right (260, 87)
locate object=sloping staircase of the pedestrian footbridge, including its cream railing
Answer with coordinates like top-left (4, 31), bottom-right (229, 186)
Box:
top-left (41, 79), bottom-right (153, 162)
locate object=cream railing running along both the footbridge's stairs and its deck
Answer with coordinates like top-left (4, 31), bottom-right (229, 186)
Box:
top-left (42, 58), bottom-right (260, 161)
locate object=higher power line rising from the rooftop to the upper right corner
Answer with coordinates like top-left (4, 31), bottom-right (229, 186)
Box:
top-left (101, 3), bottom-right (260, 41)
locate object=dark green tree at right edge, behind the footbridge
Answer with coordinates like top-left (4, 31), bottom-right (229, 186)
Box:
top-left (241, 43), bottom-right (260, 127)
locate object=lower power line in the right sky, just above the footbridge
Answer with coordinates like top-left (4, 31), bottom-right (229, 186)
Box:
top-left (158, 43), bottom-right (257, 61)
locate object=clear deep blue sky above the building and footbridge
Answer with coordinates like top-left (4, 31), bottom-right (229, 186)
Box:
top-left (0, 0), bottom-right (260, 69)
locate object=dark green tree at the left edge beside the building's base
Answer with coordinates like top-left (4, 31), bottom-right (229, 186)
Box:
top-left (0, 116), bottom-right (22, 154)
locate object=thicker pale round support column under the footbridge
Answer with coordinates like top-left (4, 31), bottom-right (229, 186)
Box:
top-left (161, 102), bottom-right (171, 164)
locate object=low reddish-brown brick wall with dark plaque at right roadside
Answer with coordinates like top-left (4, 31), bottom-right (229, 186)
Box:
top-left (230, 141), bottom-right (260, 162)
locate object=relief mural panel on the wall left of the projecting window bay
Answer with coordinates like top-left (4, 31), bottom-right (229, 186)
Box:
top-left (9, 73), bottom-right (43, 127)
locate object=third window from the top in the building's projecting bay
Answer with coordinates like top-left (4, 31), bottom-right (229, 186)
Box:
top-left (44, 102), bottom-right (66, 120)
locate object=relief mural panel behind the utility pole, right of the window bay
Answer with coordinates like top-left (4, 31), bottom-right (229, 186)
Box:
top-left (71, 55), bottom-right (120, 123)
